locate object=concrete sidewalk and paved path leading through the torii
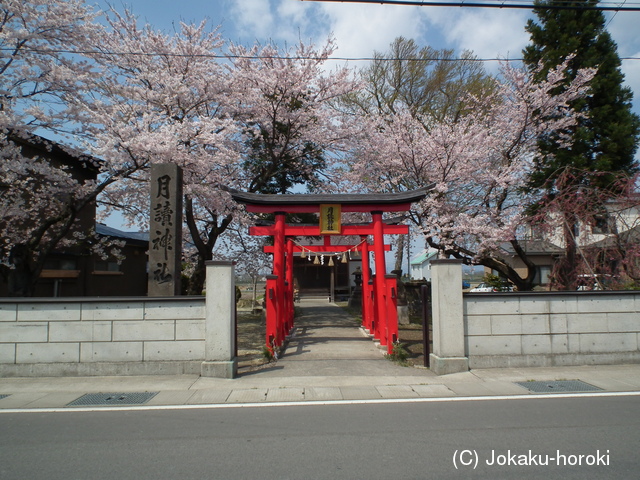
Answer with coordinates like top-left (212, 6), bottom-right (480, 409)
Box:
top-left (0, 300), bottom-right (640, 411)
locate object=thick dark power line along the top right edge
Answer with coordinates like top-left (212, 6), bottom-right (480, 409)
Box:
top-left (300, 0), bottom-right (640, 12)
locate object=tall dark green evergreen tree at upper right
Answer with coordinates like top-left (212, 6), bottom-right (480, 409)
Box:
top-left (524, 0), bottom-right (640, 190)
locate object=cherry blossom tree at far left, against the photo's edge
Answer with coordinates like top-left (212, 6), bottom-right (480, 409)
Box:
top-left (0, 0), bottom-right (136, 296)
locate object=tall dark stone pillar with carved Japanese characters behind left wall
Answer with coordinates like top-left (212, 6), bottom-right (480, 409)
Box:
top-left (147, 163), bottom-right (182, 297)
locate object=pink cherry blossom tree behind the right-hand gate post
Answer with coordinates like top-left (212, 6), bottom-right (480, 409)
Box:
top-left (350, 58), bottom-right (593, 290)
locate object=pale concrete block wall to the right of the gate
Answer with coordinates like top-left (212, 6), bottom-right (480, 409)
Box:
top-left (463, 292), bottom-right (640, 368)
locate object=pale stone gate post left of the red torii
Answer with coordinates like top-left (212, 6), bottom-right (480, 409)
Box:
top-left (201, 261), bottom-right (238, 378)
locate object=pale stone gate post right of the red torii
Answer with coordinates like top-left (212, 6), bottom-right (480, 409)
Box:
top-left (429, 259), bottom-right (469, 375)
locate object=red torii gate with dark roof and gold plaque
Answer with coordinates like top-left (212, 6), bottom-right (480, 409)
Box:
top-left (231, 187), bottom-right (431, 353)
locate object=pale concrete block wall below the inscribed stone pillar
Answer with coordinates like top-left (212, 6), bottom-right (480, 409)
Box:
top-left (0, 297), bottom-right (205, 376)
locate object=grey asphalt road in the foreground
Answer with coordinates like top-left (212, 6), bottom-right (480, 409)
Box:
top-left (0, 396), bottom-right (640, 480)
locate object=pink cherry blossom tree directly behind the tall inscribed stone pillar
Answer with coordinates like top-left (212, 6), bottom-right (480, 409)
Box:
top-left (78, 10), bottom-right (241, 294)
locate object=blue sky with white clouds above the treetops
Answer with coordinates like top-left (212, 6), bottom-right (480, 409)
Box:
top-left (98, 0), bottom-right (640, 108)
